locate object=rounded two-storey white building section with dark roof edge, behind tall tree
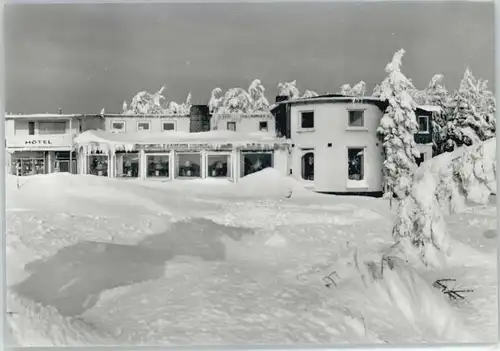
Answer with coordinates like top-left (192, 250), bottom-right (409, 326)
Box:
top-left (273, 94), bottom-right (432, 196)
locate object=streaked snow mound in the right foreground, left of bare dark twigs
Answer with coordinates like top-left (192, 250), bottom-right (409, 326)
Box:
top-left (308, 249), bottom-right (472, 342)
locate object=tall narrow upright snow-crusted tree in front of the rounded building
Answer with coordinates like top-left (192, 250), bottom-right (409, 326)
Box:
top-left (377, 49), bottom-right (420, 199)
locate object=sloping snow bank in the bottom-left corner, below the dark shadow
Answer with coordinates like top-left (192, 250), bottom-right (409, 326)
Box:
top-left (7, 292), bottom-right (116, 347)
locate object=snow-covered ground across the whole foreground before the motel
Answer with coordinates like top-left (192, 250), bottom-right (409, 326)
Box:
top-left (7, 169), bottom-right (498, 346)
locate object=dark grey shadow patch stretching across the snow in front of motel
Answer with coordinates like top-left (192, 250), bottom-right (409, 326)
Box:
top-left (13, 218), bottom-right (253, 316)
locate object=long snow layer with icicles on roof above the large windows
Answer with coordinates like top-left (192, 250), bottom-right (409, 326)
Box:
top-left (74, 130), bottom-right (286, 150)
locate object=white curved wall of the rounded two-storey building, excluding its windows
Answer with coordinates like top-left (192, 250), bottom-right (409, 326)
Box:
top-left (290, 102), bottom-right (383, 192)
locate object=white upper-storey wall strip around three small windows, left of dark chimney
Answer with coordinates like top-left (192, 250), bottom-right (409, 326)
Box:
top-left (104, 116), bottom-right (190, 133)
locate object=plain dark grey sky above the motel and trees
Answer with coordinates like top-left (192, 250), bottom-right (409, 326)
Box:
top-left (4, 1), bottom-right (494, 113)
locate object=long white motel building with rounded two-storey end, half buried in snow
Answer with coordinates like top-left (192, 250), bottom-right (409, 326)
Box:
top-left (6, 95), bottom-right (437, 195)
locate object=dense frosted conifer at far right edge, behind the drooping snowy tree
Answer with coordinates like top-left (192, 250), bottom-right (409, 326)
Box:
top-left (444, 69), bottom-right (496, 151)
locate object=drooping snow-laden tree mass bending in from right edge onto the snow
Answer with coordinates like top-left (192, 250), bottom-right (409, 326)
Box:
top-left (392, 138), bottom-right (497, 266)
